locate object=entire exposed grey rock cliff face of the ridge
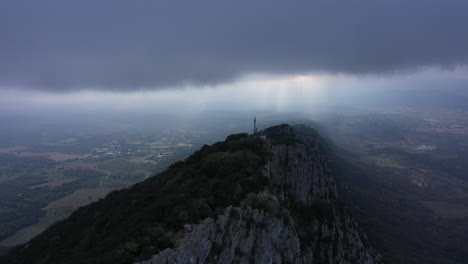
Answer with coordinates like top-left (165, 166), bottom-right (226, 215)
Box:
top-left (137, 126), bottom-right (380, 264)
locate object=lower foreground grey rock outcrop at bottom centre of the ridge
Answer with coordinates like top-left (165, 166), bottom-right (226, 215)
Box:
top-left (139, 207), bottom-right (301, 263)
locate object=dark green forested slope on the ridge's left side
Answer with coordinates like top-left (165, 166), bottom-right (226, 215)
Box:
top-left (5, 134), bottom-right (272, 263)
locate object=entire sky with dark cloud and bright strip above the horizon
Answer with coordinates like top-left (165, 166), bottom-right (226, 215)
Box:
top-left (0, 0), bottom-right (468, 114)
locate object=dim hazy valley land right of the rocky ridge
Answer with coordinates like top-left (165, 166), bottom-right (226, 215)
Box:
top-left (323, 109), bottom-right (468, 264)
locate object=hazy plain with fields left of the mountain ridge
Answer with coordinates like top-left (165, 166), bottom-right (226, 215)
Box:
top-left (0, 112), bottom-right (252, 252)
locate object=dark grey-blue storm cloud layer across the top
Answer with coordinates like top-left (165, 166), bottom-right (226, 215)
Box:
top-left (0, 0), bottom-right (468, 91)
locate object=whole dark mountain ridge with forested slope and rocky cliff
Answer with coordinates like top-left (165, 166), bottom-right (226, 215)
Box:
top-left (1, 125), bottom-right (380, 263)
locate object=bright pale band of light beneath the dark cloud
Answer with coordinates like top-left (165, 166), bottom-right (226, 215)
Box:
top-left (0, 67), bottom-right (468, 114)
